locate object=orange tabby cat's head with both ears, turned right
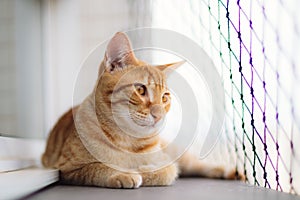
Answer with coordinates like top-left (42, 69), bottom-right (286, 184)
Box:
top-left (96, 32), bottom-right (182, 137)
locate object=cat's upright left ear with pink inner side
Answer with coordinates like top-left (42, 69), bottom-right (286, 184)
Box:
top-left (104, 32), bottom-right (137, 72)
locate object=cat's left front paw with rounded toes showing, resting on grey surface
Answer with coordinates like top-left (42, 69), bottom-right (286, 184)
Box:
top-left (107, 173), bottom-right (142, 189)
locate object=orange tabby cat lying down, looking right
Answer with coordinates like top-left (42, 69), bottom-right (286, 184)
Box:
top-left (42, 33), bottom-right (244, 188)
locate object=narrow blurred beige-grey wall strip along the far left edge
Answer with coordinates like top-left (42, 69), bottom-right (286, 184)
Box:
top-left (0, 0), bottom-right (17, 136)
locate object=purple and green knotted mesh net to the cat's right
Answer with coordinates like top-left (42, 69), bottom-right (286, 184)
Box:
top-left (195, 0), bottom-right (300, 194)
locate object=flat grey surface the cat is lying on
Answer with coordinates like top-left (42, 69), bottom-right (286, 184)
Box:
top-left (26, 178), bottom-right (300, 200)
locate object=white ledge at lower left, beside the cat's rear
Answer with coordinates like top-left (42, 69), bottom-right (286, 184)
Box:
top-left (0, 137), bottom-right (59, 199)
